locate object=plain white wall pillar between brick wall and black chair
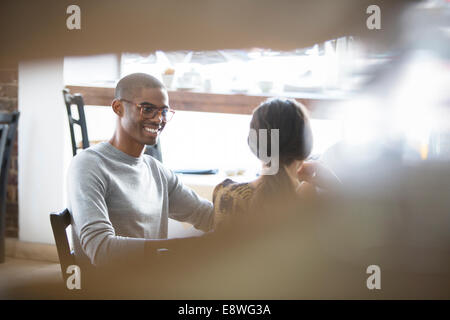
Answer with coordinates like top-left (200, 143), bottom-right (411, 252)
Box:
top-left (18, 58), bottom-right (71, 243)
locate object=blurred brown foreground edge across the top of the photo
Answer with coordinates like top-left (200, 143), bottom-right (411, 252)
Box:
top-left (0, 0), bottom-right (417, 67)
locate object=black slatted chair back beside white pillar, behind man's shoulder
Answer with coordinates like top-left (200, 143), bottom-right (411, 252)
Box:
top-left (63, 89), bottom-right (89, 156)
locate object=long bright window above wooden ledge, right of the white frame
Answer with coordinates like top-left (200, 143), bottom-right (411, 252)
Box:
top-left (121, 37), bottom-right (372, 96)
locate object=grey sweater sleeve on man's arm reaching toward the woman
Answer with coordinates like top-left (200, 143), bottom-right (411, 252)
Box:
top-left (159, 165), bottom-right (214, 232)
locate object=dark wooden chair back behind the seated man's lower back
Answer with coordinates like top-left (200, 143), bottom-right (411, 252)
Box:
top-left (50, 209), bottom-right (76, 282)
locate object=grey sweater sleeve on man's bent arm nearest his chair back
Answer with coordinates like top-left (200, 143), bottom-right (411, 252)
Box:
top-left (67, 151), bottom-right (145, 266)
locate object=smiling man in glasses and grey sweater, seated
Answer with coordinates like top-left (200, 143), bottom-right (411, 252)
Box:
top-left (68, 73), bottom-right (213, 266)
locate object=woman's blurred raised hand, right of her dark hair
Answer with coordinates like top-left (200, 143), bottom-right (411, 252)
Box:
top-left (297, 161), bottom-right (342, 189)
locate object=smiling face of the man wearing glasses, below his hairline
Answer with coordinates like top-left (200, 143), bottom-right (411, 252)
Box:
top-left (120, 88), bottom-right (169, 145)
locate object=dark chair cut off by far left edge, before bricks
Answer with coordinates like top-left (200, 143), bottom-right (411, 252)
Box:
top-left (0, 111), bottom-right (20, 263)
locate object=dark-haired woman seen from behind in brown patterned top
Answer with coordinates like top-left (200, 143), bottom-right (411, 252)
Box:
top-left (213, 99), bottom-right (339, 228)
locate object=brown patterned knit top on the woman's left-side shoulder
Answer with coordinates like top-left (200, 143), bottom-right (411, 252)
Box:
top-left (213, 179), bottom-right (254, 229)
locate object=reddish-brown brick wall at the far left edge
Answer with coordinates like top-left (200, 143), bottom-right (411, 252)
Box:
top-left (0, 66), bottom-right (18, 238)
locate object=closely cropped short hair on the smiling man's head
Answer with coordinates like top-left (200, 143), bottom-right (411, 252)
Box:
top-left (114, 73), bottom-right (165, 99)
